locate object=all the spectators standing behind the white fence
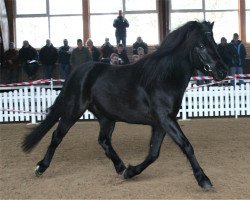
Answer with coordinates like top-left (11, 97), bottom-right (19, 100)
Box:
top-left (3, 10), bottom-right (246, 85)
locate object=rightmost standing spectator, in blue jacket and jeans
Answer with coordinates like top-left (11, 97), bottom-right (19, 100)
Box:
top-left (230, 33), bottom-right (247, 86)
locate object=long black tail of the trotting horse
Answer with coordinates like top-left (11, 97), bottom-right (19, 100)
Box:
top-left (22, 92), bottom-right (63, 153)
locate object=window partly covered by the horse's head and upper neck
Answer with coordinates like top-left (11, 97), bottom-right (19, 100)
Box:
top-left (170, 0), bottom-right (238, 42)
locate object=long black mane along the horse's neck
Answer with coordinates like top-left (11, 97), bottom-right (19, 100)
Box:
top-left (134, 21), bottom-right (214, 87)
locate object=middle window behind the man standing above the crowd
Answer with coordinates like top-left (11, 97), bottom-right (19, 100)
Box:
top-left (89, 0), bottom-right (159, 46)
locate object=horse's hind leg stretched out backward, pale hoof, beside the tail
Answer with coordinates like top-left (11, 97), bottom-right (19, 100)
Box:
top-left (35, 111), bottom-right (84, 176)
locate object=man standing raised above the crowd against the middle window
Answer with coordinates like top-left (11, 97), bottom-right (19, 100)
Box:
top-left (113, 10), bottom-right (129, 48)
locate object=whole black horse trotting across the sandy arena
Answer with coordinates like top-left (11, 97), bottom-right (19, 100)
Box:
top-left (22, 21), bottom-right (227, 189)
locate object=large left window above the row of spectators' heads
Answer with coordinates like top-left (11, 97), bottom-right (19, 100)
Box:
top-left (16, 0), bottom-right (83, 48)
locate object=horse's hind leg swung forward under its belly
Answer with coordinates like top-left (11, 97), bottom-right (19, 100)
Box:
top-left (98, 118), bottom-right (126, 174)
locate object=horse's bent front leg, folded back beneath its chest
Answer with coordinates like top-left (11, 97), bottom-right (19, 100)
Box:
top-left (123, 127), bottom-right (166, 179)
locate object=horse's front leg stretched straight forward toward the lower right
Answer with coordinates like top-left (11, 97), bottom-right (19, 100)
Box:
top-left (159, 113), bottom-right (212, 190)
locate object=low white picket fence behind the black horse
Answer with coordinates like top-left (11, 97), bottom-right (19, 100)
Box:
top-left (0, 83), bottom-right (250, 123)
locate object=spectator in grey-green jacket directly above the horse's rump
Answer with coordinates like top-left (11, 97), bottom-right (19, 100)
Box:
top-left (70, 39), bottom-right (92, 69)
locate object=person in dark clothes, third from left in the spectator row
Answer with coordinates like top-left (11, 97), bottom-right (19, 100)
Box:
top-left (39, 39), bottom-right (58, 79)
